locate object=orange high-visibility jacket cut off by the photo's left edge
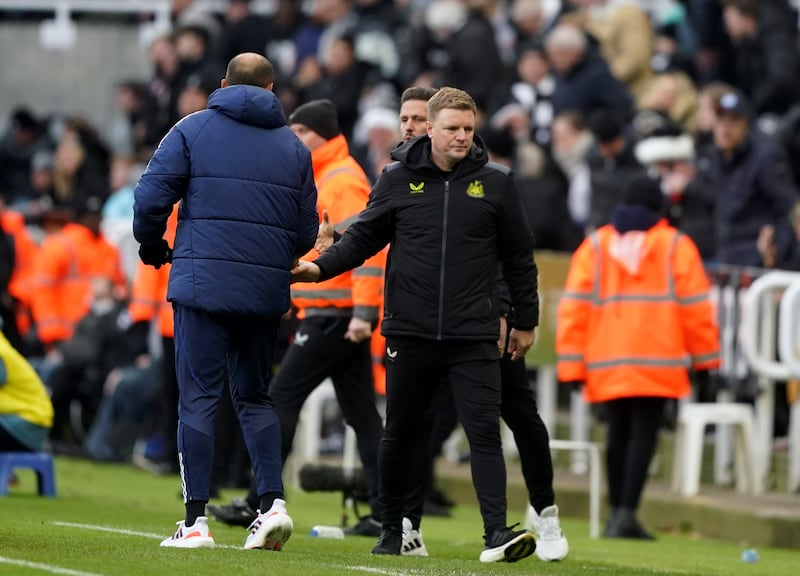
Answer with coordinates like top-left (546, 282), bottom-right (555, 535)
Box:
top-left (0, 210), bottom-right (39, 334)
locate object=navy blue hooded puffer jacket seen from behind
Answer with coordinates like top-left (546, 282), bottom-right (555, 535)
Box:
top-left (133, 85), bottom-right (319, 317)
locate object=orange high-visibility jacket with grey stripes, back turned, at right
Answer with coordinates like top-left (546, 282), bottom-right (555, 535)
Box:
top-left (556, 220), bottom-right (719, 402)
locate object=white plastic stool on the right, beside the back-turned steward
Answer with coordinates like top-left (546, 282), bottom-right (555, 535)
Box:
top-left (672, 402), bottom-right (756, 496)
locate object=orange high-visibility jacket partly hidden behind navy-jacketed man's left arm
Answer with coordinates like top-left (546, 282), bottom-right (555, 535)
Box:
top-left (128, 204), bottom-right (178, 338)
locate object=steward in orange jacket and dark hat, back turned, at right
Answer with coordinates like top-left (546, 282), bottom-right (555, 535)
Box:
top-left (556, 176), bottom-right (720, 539)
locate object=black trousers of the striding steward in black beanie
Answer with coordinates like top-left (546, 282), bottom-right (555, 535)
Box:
top-left (269, 316), bottom-right (383, 518)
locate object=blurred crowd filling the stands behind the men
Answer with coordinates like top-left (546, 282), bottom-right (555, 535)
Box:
top-left (0, 0), bottom-right (800, 482)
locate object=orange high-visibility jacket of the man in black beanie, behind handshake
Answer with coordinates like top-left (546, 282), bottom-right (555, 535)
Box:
top-left (292, 135), bottom-right (386, 319)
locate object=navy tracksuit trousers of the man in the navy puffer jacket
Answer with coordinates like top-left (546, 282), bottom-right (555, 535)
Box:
top-left (173, 304), bottom-right (283, 502)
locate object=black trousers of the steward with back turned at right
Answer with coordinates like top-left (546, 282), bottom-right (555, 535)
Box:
top-left (606, 397), bottom-right (667, 510)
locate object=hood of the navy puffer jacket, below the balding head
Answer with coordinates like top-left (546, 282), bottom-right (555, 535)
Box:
top-left (208, 84), bottom-right (286, 128)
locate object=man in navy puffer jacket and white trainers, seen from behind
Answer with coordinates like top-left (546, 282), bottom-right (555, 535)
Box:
top-left (133, 53), bottom-right (319, 550)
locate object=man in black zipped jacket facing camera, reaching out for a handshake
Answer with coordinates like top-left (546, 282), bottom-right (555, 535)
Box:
top-left (293, 88), bottom-right (539, 562)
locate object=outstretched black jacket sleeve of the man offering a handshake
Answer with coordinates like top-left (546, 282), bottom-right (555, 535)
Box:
top-left (314, 173), bottom-right (394, 282)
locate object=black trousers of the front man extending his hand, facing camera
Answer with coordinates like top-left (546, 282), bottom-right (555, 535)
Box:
top-left (379, 336), bottom-right (506, 533)
